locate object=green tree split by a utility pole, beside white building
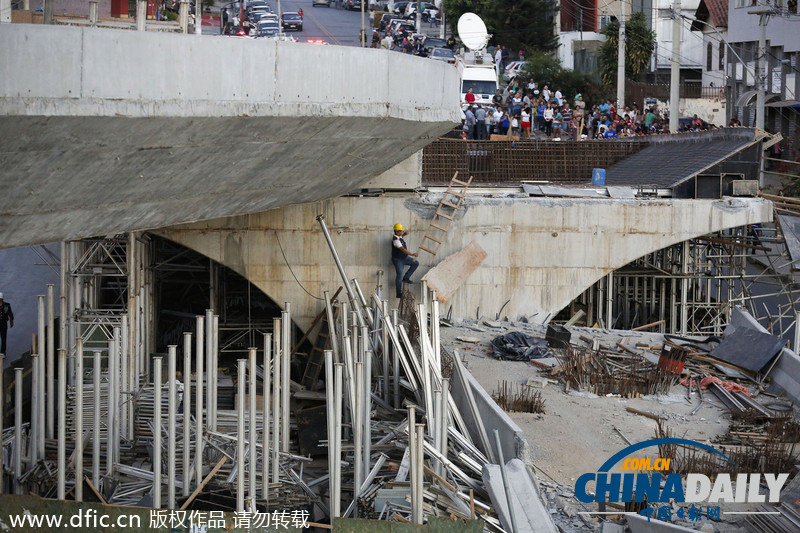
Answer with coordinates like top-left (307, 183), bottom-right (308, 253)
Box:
top-left (599, 12), bottom-right (656, 86)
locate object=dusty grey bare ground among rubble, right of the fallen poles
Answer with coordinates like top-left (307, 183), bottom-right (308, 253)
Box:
top-left (441, 320), bottom-right (780, 531)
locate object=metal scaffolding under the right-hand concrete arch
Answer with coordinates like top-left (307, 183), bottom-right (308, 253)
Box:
top-left (558, 212), bottom-right (800, 340)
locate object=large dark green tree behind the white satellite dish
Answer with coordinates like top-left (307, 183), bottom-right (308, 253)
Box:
top-left (444, 0), bottom-right (558, 53)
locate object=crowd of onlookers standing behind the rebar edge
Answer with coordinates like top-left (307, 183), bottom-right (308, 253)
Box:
top-left (462, 79), bottom-right (716, 140)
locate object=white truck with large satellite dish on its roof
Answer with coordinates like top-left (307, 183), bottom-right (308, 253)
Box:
top-left (456, 13), bottom-right (498, 108)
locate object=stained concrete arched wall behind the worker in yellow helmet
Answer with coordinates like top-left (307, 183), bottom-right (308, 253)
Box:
top-left (156, 193), bottom-right (772, 328)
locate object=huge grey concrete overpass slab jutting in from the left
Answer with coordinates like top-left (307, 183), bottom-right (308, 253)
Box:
top-left (0, 24), bottom-right (460, 248)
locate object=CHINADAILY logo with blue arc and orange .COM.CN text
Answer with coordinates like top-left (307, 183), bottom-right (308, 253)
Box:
top-left (575, 438), bottom-right (789, 516)
